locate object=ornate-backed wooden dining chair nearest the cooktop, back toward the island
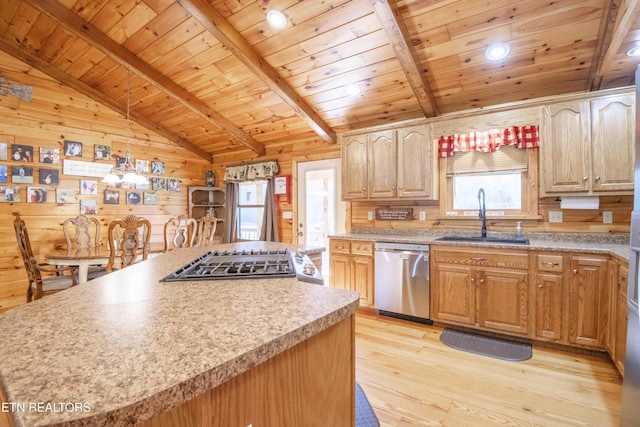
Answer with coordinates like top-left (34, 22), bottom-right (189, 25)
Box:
top-left (107, 215), bottom-right (151, 273)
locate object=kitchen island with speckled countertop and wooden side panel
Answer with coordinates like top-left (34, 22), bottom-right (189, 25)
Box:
top-left (0, 242), bottom-right (358, 426)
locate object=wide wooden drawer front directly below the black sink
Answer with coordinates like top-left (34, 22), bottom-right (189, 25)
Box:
top-left (432, 248), bottom-right (529, 269)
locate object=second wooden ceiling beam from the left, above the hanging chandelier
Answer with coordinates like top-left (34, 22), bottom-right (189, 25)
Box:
top-left (25, 0), bottom-right (265, 155)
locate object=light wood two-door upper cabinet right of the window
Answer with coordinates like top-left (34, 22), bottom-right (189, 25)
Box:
top-left (540, 94), bottom-right (635, 197)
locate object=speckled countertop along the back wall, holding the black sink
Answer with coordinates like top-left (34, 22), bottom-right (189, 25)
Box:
top-left (329, 229), bottom-right (629, 262)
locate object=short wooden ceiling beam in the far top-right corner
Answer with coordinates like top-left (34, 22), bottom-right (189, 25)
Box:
top-left (586, 0), bottom-right (640, 91)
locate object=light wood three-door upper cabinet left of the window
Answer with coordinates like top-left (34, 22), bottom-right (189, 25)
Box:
top-left (340, 124), bottom-right (438, 200)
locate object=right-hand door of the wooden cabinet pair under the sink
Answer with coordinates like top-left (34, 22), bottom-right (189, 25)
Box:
top-left (477, 269), bottom-right (529, 334)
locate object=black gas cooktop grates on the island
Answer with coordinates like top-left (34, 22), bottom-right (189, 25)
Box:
top-left (162, 250), bottom-right (296, 282)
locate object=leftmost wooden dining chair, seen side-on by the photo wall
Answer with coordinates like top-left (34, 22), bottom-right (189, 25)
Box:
top-left (13, 215), bottom-right (78, 302)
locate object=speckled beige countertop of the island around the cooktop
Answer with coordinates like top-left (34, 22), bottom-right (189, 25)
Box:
top-left (0, 242), bottom-right (359, 426)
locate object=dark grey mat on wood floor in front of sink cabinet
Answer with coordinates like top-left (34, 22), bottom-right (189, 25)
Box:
top-left (440, 329), bottom-right (532, 362)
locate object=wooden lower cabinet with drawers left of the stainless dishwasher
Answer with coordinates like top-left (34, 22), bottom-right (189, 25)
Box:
top-left (329, 239), bottom-right (374, 307)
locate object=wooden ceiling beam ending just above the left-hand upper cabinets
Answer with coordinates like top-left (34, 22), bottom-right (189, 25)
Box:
top-left (172, 0), bottom-right (337, 144)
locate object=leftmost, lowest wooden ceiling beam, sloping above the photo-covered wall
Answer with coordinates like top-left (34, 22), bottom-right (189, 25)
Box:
top-left (0, 38), bottom-right (213, 162)
